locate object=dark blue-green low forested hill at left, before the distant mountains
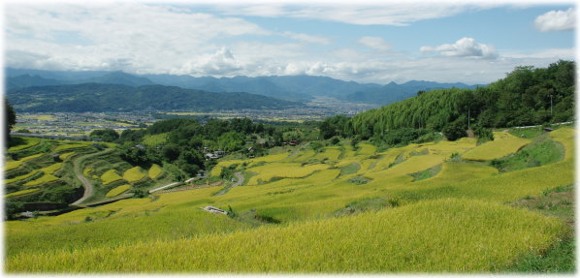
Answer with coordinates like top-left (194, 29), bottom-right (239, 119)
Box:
top-left (7, 83), bottom-right (302, 112)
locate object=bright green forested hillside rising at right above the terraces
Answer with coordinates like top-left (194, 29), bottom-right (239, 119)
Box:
top-left (321, 61), bottom-right (575, 140)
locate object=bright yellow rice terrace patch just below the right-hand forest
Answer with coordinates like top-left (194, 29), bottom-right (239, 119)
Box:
top-left (462, 132), bottom-right (531, 161)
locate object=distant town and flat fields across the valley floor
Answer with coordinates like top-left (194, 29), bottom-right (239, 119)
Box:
top-left (13, 98), bottom-right (374, 137)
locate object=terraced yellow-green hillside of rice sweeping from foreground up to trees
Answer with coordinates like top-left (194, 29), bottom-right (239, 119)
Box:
top-left (5, 127), bottom-right (575, 273)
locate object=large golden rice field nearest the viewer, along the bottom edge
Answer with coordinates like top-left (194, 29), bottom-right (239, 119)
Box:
top-left (6, 199), bottom-right (566, 273)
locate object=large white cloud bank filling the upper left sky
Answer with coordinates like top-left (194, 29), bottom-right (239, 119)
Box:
top-left (4, 2), bottom-right (271, 73)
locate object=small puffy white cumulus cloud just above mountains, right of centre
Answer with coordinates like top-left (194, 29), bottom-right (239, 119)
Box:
top-left (420, 37), bottom-right (497, 58)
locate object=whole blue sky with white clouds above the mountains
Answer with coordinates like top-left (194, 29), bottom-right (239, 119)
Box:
top-left (3, 1), bottom-right (576, 84)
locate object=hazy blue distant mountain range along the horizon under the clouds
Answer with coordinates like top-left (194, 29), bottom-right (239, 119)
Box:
top-left (5, 68), bottom-right (476, 105)
